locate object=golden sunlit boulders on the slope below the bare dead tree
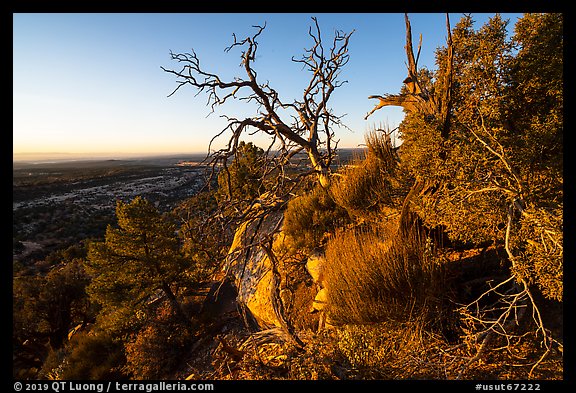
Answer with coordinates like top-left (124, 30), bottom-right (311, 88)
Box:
top-left (226, 201), bottom-right (328, 338)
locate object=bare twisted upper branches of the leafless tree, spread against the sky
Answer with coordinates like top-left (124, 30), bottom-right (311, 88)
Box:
top-left (161, 18), bottom-right (353, 191)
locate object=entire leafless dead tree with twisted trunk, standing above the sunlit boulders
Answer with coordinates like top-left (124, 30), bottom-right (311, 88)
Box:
top-left (162, 18), bottom-right (353, 346)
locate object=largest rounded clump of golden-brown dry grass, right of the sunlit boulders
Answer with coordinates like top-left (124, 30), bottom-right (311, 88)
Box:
top-left (325, 225), bottom-right (446, 323)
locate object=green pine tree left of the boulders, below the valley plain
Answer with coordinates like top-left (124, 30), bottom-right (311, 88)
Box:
top-left (88, 197), bottom-right (186, 327)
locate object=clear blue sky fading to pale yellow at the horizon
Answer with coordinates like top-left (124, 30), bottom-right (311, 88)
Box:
top-left (13, 13), bottom-right (521, 155)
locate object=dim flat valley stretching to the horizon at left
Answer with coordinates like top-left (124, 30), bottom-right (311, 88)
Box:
top-left (12, 155), bottom-right (206, 266)
